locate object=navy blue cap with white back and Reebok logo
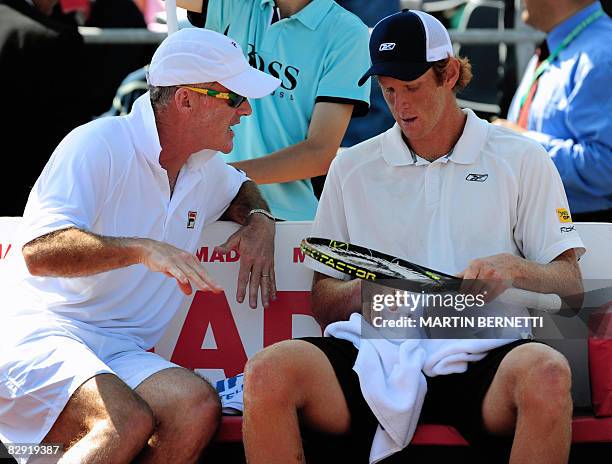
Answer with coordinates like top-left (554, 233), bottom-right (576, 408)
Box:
top-left (359, 10), bottom-right (453, 85)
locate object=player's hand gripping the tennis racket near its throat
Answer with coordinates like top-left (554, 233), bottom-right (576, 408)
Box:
top-left (457, 253), bottom-right (525, 303)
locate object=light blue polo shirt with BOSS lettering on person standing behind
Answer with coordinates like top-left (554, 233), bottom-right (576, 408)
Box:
top-left (206, 0), bottom-right (370, 220)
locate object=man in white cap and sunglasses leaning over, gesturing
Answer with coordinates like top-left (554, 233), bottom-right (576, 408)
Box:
top-left (0, 29), bottom-right (279, 463)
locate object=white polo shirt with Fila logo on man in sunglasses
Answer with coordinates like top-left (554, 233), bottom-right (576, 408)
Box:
top-left (3, 93), bottom-right (247, 349)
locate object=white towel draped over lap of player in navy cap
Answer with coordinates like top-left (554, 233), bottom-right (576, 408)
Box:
top-left (324, 313), bottom-right (513, 464)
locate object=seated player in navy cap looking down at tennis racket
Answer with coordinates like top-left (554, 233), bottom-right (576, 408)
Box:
top-left (244, 11), bottom-right (584, 464)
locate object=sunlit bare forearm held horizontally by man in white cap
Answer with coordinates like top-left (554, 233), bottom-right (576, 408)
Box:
top-left (22, 228), bottom-right (147, 277)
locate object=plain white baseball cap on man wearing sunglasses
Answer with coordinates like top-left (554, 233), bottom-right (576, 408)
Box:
top-left (148, 28), bottom-right (280, 98)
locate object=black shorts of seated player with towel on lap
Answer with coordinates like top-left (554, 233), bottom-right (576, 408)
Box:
top-left (301, 337), bottom-right (533, 452)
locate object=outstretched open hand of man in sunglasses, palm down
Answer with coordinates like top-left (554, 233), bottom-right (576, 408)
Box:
top-left (141, 239), bottom-right (222, 295)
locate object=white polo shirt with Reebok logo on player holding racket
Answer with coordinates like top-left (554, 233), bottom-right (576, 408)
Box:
top-left (306, 110), bottom-right (584, 278)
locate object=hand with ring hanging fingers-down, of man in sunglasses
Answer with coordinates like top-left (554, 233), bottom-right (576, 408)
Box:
top-left (215, 213), bottom-right (276, 309)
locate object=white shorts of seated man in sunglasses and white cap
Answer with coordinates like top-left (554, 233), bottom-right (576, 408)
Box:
top-left (0, 316), bottom-right (179, 462)
